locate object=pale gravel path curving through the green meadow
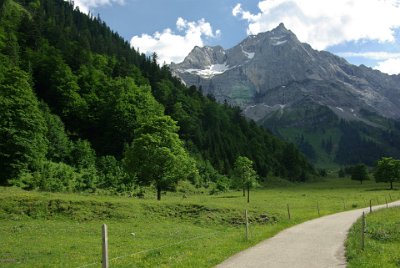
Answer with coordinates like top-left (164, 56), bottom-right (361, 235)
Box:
top-left (216, 201), bottom-right (400, 268)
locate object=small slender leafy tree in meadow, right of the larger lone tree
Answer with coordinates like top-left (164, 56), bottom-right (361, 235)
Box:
top-left (234, 156), bottom-right (257, 203)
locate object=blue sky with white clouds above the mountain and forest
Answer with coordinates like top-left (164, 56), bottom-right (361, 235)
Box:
top-left (74, 0), bottom-right (400, 74)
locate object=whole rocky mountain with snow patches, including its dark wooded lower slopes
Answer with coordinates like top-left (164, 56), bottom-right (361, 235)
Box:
top-left (170, 24), bottom-right (400, 165)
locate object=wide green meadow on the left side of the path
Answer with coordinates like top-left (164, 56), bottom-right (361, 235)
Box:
top-left (0, 179), bottom-right (400, 267)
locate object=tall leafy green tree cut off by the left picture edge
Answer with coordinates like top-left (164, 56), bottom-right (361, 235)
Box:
top-left (0, 68), bottom-right (48, 185)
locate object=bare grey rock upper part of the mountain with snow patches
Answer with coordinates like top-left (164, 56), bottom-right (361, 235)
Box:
top-left (170, 24), bottom-right (400, 125)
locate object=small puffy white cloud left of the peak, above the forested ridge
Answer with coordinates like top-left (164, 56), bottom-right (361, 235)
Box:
top-left (131, 18), bottom-right (221, 64)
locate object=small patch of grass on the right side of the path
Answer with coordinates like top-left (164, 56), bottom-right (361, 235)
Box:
top-left (346, 207), bottom-right (400, 268)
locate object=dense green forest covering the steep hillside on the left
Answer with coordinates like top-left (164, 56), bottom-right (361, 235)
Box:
top-left (0, 0), bottom-right (314, 195)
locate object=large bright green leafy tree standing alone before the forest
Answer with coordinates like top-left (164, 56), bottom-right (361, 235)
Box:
top-left (124, 116), bottom-right (198, 200)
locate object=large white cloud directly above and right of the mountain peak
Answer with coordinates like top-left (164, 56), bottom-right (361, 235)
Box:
top-left (232, 0), bottom-right (400, 49)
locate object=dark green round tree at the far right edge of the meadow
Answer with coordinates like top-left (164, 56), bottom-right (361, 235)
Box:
top-left (374, 157), bottom-right (400, 190)
